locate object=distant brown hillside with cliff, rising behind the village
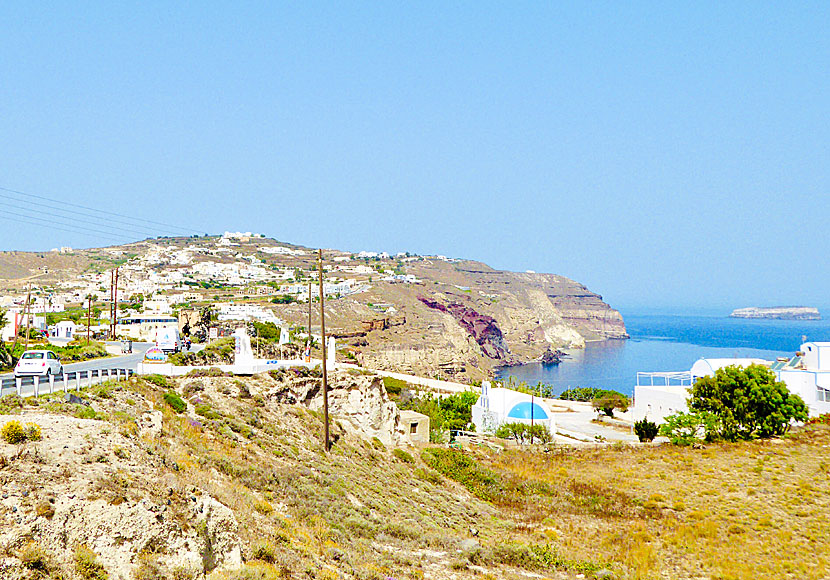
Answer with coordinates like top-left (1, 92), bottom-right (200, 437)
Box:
top-left (0, 236), bottom-right (627, 382)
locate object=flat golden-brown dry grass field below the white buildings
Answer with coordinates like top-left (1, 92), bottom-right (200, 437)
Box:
top-left (472, 426), bottom-right (830, 579)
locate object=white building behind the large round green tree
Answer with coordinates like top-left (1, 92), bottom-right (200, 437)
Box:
top-left (632, 342), bottom-right (830, 424)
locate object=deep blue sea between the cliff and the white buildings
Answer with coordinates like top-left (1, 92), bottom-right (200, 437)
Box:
top-left (496, 312), bottom-right (830, 395)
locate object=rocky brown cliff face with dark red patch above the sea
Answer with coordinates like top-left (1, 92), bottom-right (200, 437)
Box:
top-left (314, 260), bottom-right (628, 381)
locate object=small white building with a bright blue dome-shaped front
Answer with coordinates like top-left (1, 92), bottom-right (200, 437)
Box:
top-left (473, 381), bottom-right (556, 433)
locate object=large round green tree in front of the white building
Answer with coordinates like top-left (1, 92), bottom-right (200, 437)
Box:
top-left (689, 364), bottom-right (808, 441)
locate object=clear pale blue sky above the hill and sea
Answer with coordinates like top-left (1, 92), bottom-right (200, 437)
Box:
top-left (0, 2), bottom-right (830, 309)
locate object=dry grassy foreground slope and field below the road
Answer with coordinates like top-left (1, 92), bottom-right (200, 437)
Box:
top-left (0, 371), bottom-right (830, 580)
